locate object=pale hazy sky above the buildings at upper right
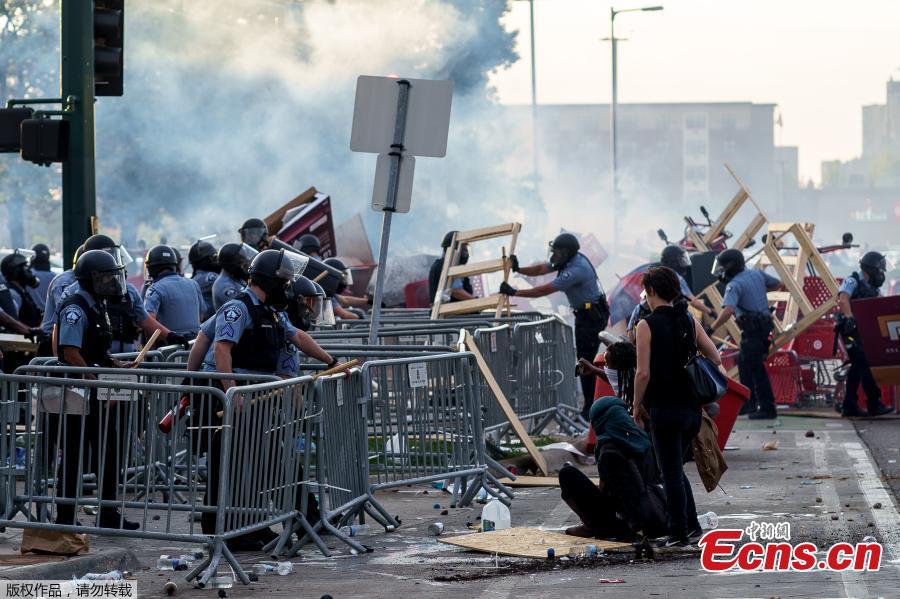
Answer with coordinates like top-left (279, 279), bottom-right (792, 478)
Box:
top-left (493, 0), bottom-right (900, 181)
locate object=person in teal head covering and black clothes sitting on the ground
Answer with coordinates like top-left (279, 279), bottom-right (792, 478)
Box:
top-left (559, 397), bottom-right (666, 541)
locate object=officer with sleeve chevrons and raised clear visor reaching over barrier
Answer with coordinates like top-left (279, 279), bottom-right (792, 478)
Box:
top-left (201, 250), bottom-right (337, 546)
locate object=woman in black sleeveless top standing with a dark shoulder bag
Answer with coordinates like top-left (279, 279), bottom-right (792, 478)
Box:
top-left (633, 266), bottom-right (722, 547)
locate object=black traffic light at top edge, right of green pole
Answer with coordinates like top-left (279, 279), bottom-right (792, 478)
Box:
top-left (94, 0), bottom-right (125, 96)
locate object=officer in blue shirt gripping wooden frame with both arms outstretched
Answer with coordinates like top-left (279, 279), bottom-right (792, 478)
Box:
top-left (500, 233), bottom-right (609, 420)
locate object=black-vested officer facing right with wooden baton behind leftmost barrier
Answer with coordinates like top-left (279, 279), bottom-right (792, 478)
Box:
top-left (50, 250), bottom-right (140, 530)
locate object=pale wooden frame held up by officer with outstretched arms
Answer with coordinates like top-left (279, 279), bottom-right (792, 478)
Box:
top-left (431, 223), bottom-right (522, 319)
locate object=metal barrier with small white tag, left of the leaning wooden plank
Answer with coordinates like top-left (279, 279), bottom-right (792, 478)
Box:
top-left (362, 352), bottom-right (512, 506)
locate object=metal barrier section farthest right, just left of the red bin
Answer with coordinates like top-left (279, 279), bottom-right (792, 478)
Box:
top-left (512, 316), bottom-right (582, 434)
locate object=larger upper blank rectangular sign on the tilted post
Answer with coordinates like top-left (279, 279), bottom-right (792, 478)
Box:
top-left (350, 75), bottom-right (453, 158)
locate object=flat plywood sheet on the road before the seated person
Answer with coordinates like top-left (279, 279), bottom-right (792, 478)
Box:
top-left (438, 527), bottom-right (634, 559)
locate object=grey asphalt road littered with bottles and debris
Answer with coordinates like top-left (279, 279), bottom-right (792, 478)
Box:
top-left (114, 417), bottom-right (900, 599)
